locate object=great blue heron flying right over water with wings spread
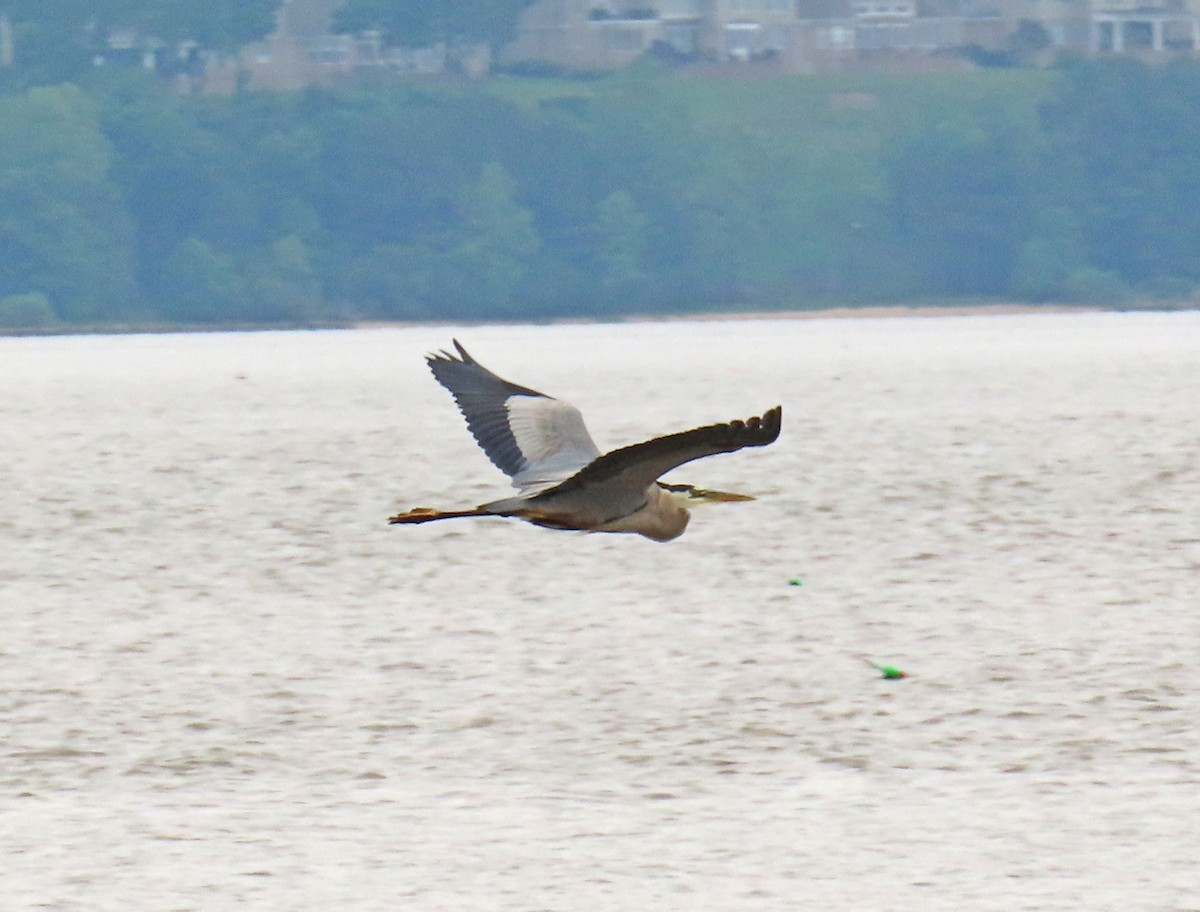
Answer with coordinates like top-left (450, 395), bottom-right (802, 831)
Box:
top-left (388, 340), bottom-right (782, 541)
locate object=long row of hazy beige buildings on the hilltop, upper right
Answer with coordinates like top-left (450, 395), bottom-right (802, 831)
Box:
top-left (500, 0), bottom-right (1200, 72)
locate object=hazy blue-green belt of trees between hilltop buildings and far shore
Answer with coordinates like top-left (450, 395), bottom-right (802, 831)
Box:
top-left (0, 60), bottom-right (1200, 326)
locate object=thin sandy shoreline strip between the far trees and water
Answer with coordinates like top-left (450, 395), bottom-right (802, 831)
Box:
top-left (0, 301), bottom-right (1200, 338)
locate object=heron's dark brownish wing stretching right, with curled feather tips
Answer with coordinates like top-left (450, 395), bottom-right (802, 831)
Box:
top-left (539, 406), bottom-right (784, 516)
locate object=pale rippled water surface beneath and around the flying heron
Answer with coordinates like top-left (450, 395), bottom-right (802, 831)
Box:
top-left (0, 313), bottom-right (1200, 912)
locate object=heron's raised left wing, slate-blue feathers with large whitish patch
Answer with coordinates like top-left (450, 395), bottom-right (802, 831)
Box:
top-left (426, 340), bottom-right (600, 488)
